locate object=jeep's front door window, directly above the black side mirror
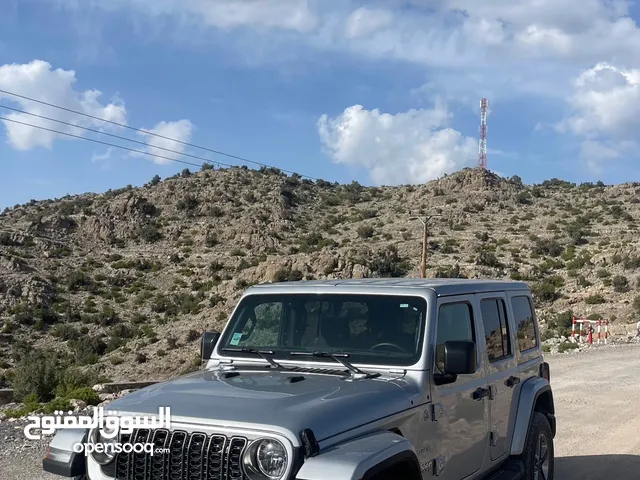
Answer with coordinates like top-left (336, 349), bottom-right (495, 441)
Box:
top-left (435, 302), bottom-right (476, 373)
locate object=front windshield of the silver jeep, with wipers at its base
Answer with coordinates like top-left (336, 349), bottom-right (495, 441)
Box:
top-left (219, 293), bottom-right (427, 366)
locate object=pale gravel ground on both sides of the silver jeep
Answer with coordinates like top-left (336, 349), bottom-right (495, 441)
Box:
top-left (0, 345), bottom-right (640, 480)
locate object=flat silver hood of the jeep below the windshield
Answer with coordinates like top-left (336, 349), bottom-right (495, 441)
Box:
top-left (103, 369), bottom-right (418, 441)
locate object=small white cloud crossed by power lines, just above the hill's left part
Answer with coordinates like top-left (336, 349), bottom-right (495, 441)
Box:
top-left (131, 119), bottom-right (195, 165)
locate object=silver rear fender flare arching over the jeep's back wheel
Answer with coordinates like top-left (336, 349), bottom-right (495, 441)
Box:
top-left (511, 377), bottom-right (556, 455)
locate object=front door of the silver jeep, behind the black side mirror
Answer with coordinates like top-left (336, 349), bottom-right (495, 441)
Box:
top-left (432, 295), bottom-right (489, 480)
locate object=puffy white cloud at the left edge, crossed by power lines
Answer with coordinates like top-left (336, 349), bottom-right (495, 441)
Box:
top-left (0, 60), bottom-right (127, 150)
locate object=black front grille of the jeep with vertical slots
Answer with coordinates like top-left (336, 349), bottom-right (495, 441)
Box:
top-left (102, 429), bottom-right (247, 480)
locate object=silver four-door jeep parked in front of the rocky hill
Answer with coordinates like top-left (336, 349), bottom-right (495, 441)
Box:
top-left (43, 278), bottom-right (556, 480)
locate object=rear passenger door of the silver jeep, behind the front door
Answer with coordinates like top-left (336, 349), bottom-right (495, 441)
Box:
top-left (477, 293), bottom-right (519, 460)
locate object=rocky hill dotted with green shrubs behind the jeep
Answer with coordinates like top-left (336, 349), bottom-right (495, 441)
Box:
top-left (0, 167), bottom-right (640, 398)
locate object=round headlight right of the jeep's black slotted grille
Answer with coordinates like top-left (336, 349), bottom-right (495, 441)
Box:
top-left (244, 438), bottom-right (288, 480)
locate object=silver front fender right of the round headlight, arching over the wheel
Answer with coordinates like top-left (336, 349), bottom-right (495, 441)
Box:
top-left (296, 431), bottom-right (422, 480)
